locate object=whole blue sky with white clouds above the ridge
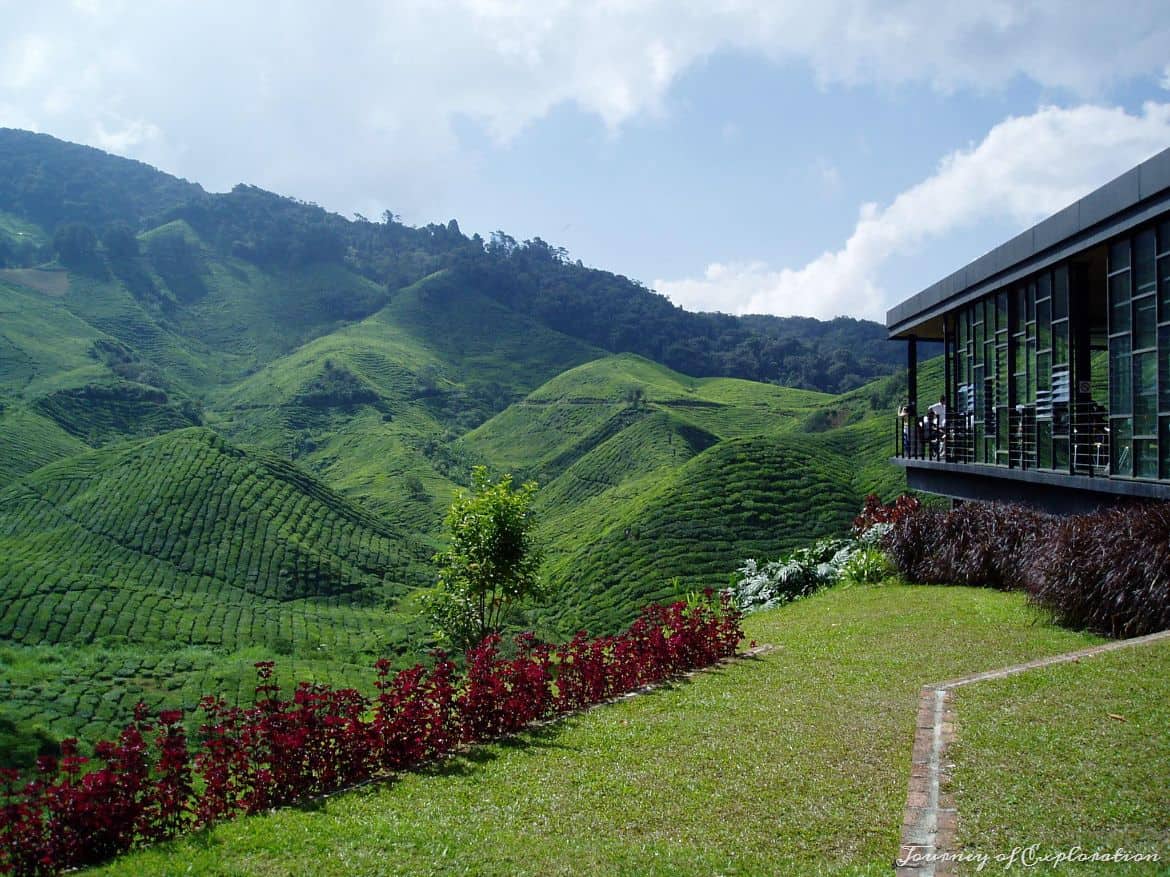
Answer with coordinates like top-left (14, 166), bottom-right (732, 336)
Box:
top-left (0, 0), bottom-right (1170, 320)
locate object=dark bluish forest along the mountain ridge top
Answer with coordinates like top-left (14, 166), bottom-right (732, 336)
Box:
top-left (0, 129), bottom-right (899, 392)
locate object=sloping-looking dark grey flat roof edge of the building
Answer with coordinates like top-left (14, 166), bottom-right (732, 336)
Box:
top-left (886, 149), bottom-right (1170, 338)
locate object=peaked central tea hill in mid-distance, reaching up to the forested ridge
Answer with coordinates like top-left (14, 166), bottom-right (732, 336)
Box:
top-left (207, 272), bottom-right (600, 534)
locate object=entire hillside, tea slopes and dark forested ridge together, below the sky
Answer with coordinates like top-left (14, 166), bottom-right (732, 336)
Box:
top-left (0, 131), bottom-right (931, 761)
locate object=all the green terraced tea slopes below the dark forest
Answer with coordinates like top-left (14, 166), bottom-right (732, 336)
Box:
top-left (0, 257), bottom-right (929, 758)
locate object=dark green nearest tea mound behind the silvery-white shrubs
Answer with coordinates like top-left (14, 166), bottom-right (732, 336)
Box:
top-left (546, 435), bottom-right (861, 630)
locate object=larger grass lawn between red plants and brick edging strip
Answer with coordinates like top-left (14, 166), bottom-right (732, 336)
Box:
top-left (91, 585), bottom-right (1104, 876)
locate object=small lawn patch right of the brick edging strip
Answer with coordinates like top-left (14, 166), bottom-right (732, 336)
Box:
top-left (949, 641), bottom-right (1170, 875)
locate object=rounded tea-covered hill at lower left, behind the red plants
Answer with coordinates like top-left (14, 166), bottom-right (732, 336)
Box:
top-left (0, 429), bottom-right (439, 760)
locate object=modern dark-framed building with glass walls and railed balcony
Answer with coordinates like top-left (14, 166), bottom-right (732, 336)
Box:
top-left (886, 149), bottom-right (1170, 511)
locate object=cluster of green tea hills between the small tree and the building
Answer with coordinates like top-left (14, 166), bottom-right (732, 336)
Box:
top-left (462, 354), bottom-right (912, 634)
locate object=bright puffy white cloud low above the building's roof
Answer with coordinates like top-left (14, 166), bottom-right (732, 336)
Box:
top-left (654, 103), bottom-right (1170, 319)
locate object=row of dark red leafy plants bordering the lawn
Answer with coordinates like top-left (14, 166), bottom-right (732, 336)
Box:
top-left (0, 592), bottom-right (743, 876)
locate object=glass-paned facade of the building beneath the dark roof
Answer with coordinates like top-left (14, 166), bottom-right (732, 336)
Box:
top-left (943, 220), bottom-right (1170, 481)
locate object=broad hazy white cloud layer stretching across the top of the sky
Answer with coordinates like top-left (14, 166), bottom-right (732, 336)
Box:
top-left (0, 0), bottom-right (1170, 219)
